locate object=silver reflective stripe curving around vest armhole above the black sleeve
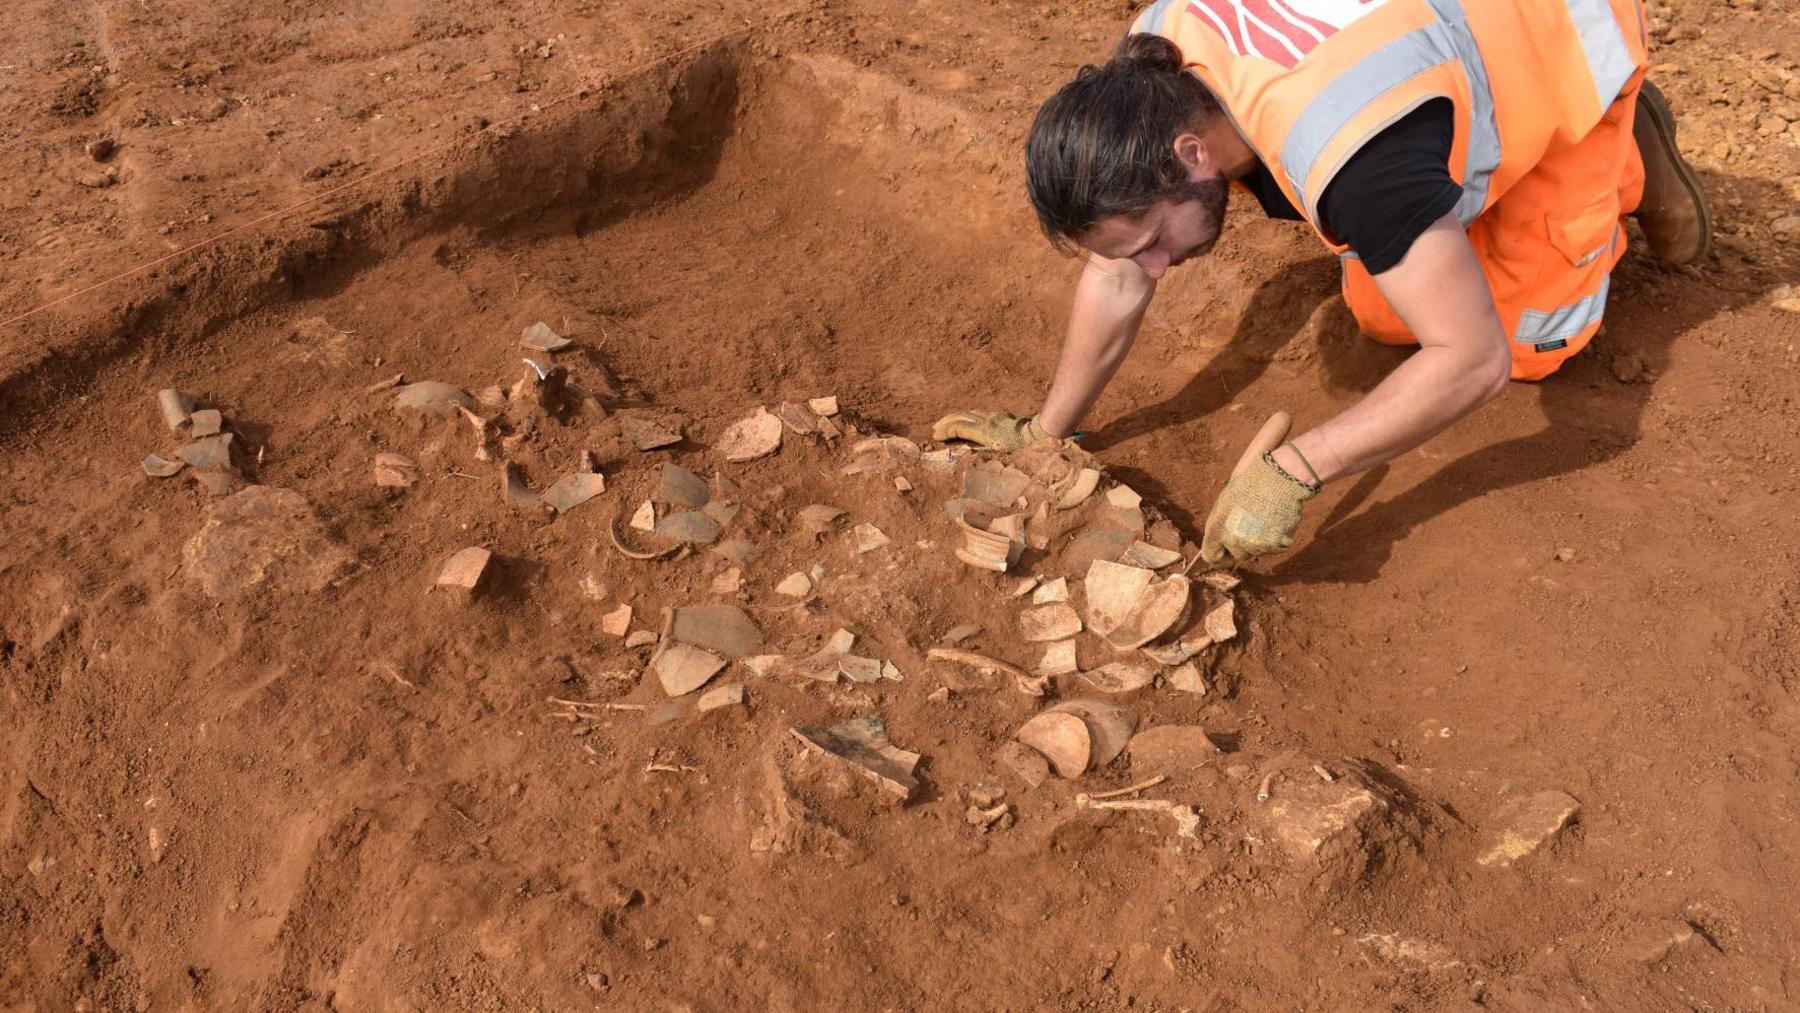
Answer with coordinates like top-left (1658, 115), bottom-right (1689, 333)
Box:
top-left (1282, 0), bottom-right (1499, 227)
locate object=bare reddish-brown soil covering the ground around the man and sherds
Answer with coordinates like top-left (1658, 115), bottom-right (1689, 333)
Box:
top-left (0, 0), bottom-right (1800, 1009)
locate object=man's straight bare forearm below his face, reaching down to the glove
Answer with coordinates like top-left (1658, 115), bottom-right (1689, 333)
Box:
top-left (1037, 255), bottom-right (1156, 435)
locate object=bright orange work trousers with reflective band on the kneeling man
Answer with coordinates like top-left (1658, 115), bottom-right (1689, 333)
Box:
top-left (1341, 0), bottom-right (1647, 380)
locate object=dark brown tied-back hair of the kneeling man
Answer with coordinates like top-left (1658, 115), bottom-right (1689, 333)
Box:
top-left (1024, 34), bottom-right (1219, 252)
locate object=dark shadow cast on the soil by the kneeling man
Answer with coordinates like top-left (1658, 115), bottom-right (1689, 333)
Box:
top-left (1093, 173), bottom-right (1786, 583)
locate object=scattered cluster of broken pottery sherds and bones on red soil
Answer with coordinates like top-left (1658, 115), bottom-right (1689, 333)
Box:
top-left (144, 314), bottom-right (1575, 865)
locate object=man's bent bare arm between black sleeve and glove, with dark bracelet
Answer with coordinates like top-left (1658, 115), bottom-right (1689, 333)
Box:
top-left (1274, 214), bottom-right (1512, 482)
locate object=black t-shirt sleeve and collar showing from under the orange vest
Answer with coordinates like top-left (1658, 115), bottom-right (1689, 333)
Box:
top-left (1238, 99), bottom-right (1462, 273)
